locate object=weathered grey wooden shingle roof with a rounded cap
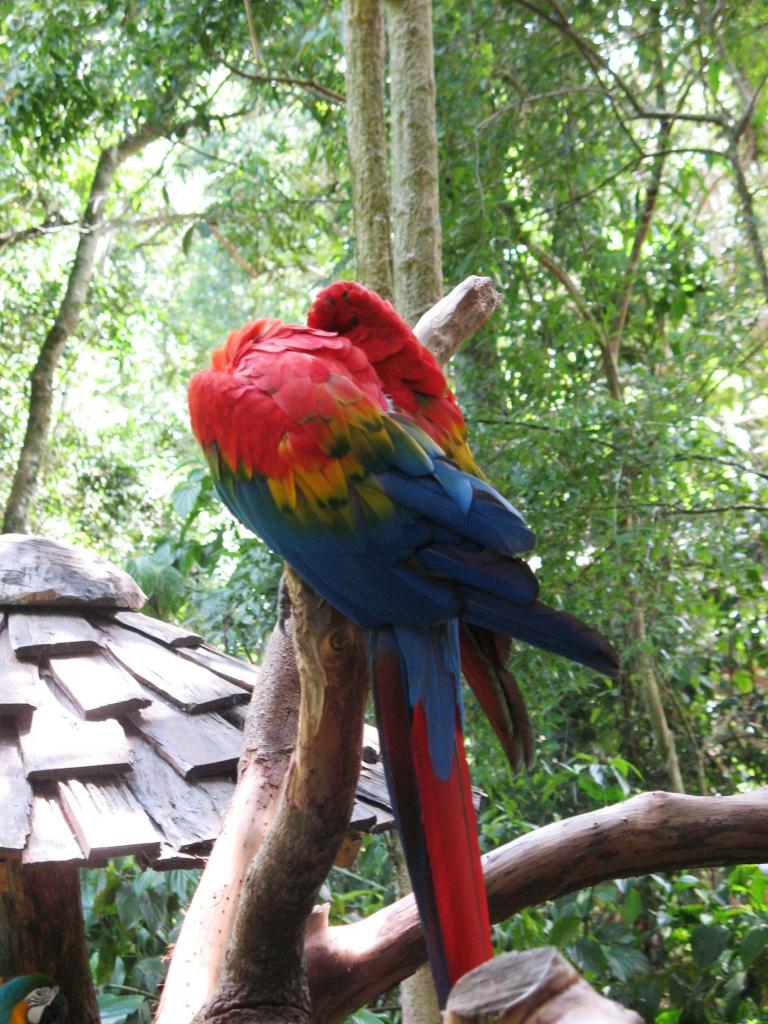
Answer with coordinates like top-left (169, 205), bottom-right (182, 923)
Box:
top-left (0, 535), bottom-right (392, 867)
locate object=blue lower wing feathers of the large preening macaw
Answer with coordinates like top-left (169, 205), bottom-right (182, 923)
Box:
top-left (210, 407), bottom-right (616, 679)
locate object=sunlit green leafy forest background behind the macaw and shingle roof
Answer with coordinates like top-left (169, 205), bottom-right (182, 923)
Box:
top-left (0, 0), bottom-right (768, 1024)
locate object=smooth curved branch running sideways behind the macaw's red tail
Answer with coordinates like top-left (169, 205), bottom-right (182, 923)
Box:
top-left (306, 788), bottom-right (768, 1024)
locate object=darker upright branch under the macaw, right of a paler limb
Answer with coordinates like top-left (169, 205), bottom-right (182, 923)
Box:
top-left (195, 569), bottom-right (368, 1024)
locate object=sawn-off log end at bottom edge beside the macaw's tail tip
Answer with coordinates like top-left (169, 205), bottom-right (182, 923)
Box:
top-left (442, 946), bottom-right (642, 1024)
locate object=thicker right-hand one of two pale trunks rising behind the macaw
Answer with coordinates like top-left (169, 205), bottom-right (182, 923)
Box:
top-left (387, 0), bottom-right (442, 324)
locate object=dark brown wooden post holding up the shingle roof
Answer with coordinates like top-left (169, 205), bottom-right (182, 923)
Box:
top-left (0, 861), bottom-right (99, 1024)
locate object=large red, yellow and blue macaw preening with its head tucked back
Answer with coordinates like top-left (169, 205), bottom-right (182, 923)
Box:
top-left (189, 282), bottom-right (616, 1005)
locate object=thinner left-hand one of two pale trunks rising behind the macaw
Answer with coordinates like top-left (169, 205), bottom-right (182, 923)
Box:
top-left (342, 0), bottom-right (394, 300)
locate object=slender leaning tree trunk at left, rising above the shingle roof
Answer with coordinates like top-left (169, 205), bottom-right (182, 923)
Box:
top-left (3, 128), bottom-right (159, 534)
